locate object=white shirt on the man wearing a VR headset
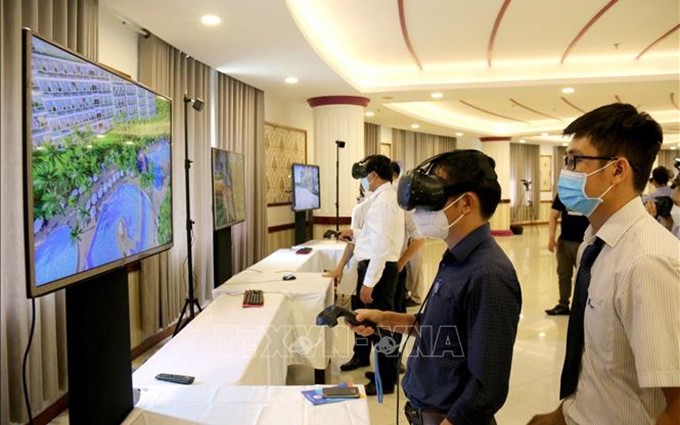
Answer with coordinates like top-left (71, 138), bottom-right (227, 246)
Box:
top-left (353, 183), bottom-right (404, 288)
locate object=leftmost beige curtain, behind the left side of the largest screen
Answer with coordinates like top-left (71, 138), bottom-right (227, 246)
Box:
top-left (0, 0), bottom-right (98, 424)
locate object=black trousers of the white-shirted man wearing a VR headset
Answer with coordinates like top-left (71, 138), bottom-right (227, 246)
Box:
top-left (352, 260), bottom-right (403, 389)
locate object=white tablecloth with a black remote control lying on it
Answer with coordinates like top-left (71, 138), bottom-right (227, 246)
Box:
top-left (132, 294), bottom-right (292, 392)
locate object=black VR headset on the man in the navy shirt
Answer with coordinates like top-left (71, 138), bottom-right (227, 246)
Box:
top-left (397, 149), bottom-right (498, 211)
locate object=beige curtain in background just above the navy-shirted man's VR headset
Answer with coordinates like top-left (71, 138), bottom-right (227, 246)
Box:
top-left (392, 129), bottom-right (456, 171)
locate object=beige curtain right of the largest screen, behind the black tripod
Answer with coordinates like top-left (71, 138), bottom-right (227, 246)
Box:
top-left (136, 35), bottom-right (213, 330)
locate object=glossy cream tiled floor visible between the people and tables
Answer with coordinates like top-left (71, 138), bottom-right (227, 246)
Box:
top-left (52, 226), bottom-right (568, 425)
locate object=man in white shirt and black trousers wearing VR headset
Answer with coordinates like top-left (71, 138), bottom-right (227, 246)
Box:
top-left (341, 155), bottom-right (404, 395)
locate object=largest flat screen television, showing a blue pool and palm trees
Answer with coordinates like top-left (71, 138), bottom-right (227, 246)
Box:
top-left (23, 29), bottom-right (173, 297)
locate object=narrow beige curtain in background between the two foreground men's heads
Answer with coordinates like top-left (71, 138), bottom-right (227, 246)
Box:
top-left (510, 143), bottom-right (541, 223)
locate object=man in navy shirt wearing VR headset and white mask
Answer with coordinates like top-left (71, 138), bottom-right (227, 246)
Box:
top-left (353, 150), bottom-right (522, 425)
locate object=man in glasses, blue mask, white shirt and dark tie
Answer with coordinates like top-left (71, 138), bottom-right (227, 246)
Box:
top-left (529, 103), bottom-right (680, 425)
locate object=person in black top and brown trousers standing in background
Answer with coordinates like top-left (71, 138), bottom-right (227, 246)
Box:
top-left (545, 196), bottom-right (589, 316)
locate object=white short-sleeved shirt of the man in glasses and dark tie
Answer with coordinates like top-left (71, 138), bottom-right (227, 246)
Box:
top-left (563, 197), bottom-right (680, 425)
